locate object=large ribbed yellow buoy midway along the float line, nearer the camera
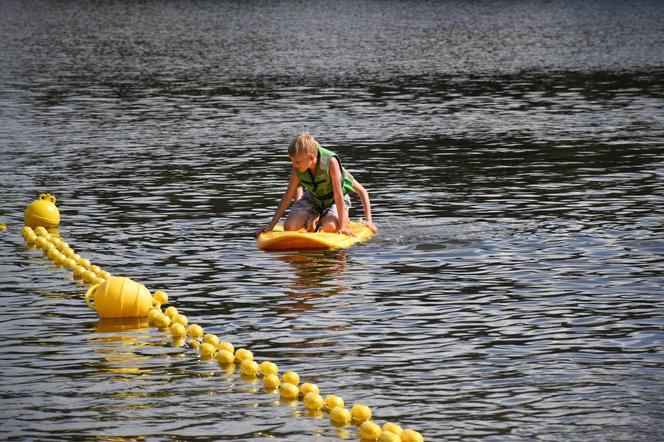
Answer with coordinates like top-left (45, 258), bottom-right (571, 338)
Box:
top-left (85, 276), bottom-right (158, 318)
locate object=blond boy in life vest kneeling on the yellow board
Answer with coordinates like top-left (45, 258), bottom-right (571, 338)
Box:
top-left (258, 132), bottom-right (378, 236)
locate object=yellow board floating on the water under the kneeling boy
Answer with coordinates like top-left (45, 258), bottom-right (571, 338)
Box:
top-left (256, 221), bottom-right (373, 250)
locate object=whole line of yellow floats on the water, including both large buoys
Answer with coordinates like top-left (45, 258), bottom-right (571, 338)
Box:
top-left (22, 194), bottom-right (424, 442)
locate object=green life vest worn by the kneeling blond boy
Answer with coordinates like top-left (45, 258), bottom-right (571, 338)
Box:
top-left (295, 147), bottom-right (353, 209)
